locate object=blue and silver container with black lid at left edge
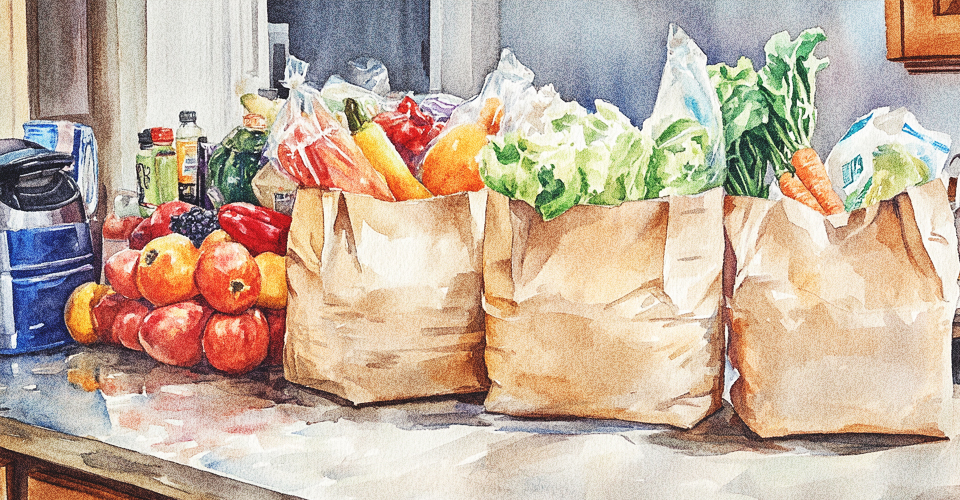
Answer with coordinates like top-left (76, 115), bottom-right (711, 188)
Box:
top-left (0, 139), bottom-right (100, 354)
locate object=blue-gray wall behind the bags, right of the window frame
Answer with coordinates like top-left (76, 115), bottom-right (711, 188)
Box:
top-left (500, 0), bottom-right (960, 158)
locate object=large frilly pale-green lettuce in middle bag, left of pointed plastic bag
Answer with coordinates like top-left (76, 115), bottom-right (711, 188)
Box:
top-left (479, 97), bottom-right (653, 220)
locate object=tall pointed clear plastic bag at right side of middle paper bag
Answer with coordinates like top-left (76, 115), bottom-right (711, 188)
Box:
top-left (642, 24), bottom-right (726, 196)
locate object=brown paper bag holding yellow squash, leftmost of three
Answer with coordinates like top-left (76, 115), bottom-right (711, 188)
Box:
top-left (284, 189), bottom-right (488, 404)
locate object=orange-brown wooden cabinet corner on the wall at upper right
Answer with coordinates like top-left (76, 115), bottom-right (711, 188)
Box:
top-left (885, 0), bottom-right (960, 74)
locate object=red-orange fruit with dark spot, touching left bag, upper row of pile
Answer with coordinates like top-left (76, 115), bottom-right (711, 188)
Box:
top-left (194, 241), bottom-right (261, 314)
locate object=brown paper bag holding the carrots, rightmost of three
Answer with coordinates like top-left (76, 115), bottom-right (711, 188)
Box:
top-left (724, 181), bottom-right (960, 437)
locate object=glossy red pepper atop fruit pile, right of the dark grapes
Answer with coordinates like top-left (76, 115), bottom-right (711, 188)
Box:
top-left (217, 202), bottom-right (293, 255)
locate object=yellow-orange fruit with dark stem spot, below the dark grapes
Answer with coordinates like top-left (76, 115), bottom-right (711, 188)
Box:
top-left (136, 233), bottom-right (200, 306)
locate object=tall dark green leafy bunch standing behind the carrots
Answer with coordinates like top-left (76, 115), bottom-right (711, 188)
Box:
top-left (707, 28), bottom-right (828, 198)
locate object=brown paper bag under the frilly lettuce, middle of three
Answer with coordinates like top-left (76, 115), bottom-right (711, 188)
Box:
top-left (484, 189), bottom-right (724, 428)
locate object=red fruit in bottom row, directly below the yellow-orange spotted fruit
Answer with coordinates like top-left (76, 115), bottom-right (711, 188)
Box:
top-left (139, 300), bottom-right (213, 367)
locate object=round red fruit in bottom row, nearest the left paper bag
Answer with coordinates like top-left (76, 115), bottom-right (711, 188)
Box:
top-left (203, 308), bottom-right (270, 375)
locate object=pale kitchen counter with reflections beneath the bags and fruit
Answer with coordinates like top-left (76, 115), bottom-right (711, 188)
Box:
top-left (0, 346), bottom-right (960, 500)
